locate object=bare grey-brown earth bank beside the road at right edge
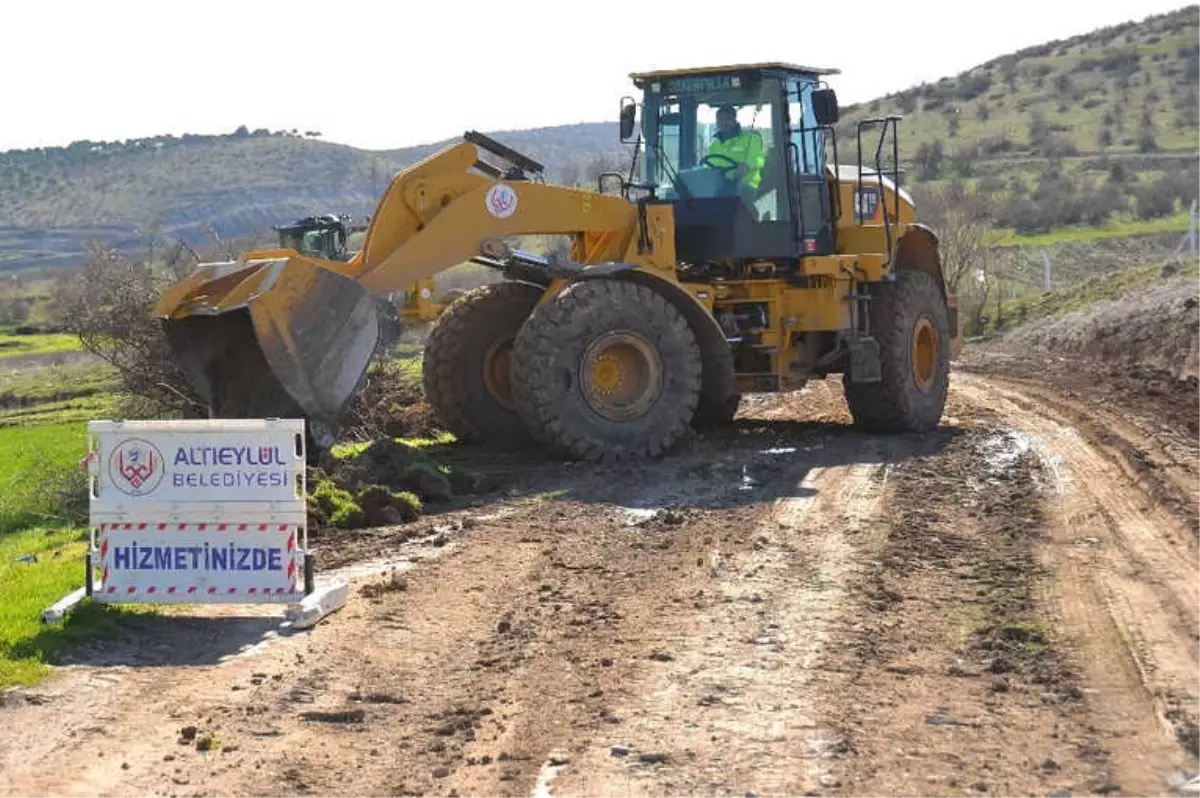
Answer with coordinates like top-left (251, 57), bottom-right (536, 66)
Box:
top-left (1002, 277), bottom-right (1200, 385)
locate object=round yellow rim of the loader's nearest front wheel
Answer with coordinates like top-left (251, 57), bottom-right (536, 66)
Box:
top-left (580, 332), bottom-right (662, 421)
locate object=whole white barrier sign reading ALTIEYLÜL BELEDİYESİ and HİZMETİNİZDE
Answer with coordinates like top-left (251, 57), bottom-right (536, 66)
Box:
top-left (86, 419), bottom-right (312, 604)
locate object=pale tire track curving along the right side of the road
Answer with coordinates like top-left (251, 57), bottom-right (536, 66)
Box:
top-left (953, 376), bottom-right (1200, 782)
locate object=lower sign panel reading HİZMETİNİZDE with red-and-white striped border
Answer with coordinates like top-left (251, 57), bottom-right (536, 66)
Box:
top-left (97, 522), bottom-right (304, 604)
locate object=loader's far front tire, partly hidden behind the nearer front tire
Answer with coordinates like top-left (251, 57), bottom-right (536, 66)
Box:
top-left (422, 282), bottom-right (542, 446)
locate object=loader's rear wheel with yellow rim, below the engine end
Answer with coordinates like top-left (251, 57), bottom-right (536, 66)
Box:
top-left (842, 271), bottom-right (950, 433)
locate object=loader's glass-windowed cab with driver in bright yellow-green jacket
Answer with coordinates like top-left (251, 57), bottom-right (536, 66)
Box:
top-left (622, 64), bottom-right (836, 263)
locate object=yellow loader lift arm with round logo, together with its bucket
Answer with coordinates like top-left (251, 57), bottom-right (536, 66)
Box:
top-left (155, 132), bottom-right (674, 445)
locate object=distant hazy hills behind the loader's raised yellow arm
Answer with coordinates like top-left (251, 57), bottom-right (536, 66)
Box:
top-left (0, 122), bottom-right (622, 270)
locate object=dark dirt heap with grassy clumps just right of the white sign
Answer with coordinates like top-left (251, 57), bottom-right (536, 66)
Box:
top-left (308, 437), bottom-right (487, 533)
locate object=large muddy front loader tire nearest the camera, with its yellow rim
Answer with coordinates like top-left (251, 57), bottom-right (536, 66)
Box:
top-left (512, 280), bottom-right (701, 462)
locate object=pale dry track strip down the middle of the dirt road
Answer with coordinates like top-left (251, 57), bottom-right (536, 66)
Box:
top-left (550, 442), bottom-right (889, 798)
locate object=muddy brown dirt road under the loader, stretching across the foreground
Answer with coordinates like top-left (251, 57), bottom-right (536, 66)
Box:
top-left (0, 358), bottom-right (1200, 798)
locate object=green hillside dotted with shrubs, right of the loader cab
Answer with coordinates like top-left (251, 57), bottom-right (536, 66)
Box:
top-left (839, 6), bottom-right (1200, 234)
